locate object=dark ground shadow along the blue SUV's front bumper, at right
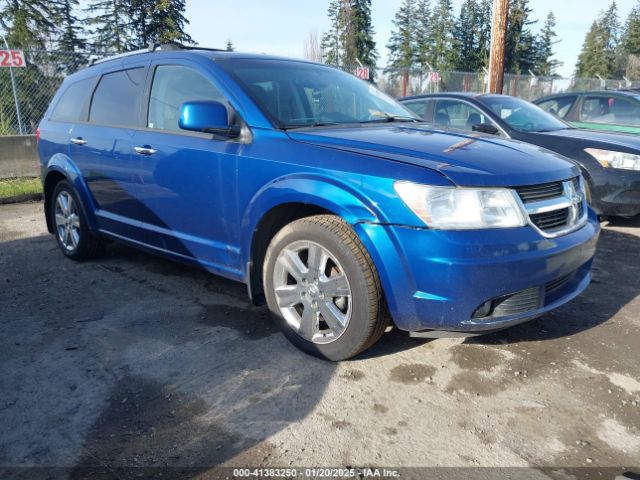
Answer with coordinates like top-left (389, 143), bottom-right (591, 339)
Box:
top-left (465, 223), bottom-right (640, 345)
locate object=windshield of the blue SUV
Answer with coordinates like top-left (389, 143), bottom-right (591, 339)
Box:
top-left (220, 59), bottom-right (420, 128)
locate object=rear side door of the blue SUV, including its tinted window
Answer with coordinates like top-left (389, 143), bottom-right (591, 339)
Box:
top-left (70, 62), bottom-right (148, 241)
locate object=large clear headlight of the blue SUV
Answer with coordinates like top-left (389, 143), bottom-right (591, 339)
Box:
top-left (394, 182), bottom-right (527, 230)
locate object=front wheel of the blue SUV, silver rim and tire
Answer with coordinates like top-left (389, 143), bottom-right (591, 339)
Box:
top-left (263, 215), bottom-right (388, 361)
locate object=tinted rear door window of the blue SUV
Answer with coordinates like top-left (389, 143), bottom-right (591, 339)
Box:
top-left (89, 67), bottom-right (145, 127)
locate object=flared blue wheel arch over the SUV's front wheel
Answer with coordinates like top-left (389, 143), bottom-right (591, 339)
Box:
top-left (241, 174), bottom-right (382, 265)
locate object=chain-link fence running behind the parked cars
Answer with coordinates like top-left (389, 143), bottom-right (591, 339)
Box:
top-left (0, 50), bottom-right (640, 135)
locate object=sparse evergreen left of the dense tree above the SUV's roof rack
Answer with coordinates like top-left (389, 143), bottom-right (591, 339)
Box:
top-left (87, 0), bottom-right (133, 53)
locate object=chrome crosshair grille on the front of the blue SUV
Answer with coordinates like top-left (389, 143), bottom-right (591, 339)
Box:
top-left (515, 177), bottom-right (586, 237)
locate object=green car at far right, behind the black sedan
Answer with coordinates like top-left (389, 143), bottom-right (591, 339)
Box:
top-left (533, 90), bottom-right (640, 135)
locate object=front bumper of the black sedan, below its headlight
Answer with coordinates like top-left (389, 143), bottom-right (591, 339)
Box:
top-left (589, 168), bottom-right (640, 217)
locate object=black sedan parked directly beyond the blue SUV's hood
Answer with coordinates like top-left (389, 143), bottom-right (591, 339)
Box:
top-left (401, 93), bottom-right (640, 217)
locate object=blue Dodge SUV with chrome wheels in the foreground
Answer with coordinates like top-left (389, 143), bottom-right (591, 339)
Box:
top-left (38, 46), bottom-right (599, 360)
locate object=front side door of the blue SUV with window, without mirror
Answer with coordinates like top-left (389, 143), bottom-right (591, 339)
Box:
top-left (133, 59), bottom-right (244, 270)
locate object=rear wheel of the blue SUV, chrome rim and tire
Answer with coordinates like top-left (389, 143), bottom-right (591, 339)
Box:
top-left (49, 180), bottom-right (106, 261)
